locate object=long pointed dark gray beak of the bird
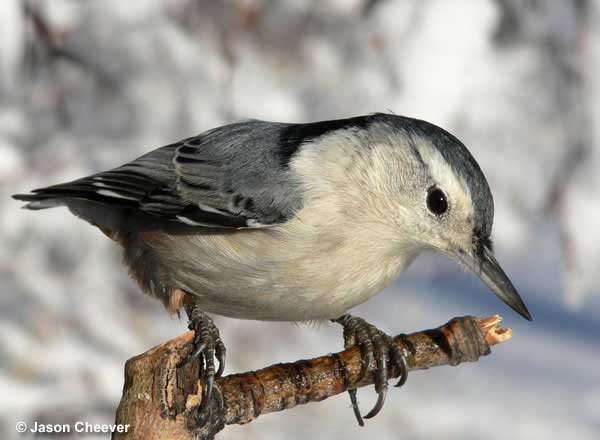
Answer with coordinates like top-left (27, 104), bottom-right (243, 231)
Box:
top-left (457, 243), bottom-right (532, 321)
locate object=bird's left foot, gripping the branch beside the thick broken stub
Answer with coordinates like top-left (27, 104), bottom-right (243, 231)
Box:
top-left (184, 305), bottom-right (225, 418)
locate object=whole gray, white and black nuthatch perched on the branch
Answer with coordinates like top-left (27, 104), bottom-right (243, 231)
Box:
top-left (13, 113), bottom-right (532, 426)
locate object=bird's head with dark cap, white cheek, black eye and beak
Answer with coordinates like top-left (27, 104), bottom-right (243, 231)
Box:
top-left (354, 115), bottom-right (531, 320)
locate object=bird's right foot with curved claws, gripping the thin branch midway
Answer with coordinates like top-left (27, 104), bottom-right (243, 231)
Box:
top-left (333, 315), bottom-right (408, 426)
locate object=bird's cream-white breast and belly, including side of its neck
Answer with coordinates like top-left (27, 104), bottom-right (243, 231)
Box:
top-left (159, 132), bottom-right (419, 321)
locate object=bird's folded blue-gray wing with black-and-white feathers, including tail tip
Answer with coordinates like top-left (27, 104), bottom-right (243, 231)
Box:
top-left (13, 121), bottom-right (302, 228)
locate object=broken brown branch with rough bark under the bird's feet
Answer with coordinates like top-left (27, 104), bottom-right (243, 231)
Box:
top-left (114, 315), bottom-right (512, 440)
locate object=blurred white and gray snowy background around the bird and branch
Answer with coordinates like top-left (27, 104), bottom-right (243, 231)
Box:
top-left (0, 0), bottom-right (600, 440)
